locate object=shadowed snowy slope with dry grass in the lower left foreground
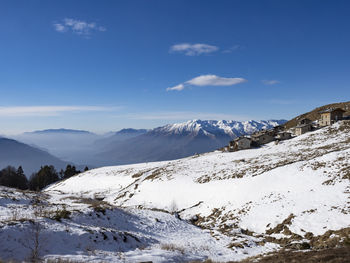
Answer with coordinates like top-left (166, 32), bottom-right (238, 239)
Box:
top-left (0, 187), bottom-right (249, 262)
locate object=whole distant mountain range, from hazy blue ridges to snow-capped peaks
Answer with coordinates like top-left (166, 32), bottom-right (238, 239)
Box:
top-left (4, 120), bottom-right (285, 168)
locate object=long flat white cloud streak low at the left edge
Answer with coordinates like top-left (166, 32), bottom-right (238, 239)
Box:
top-left (0, 106), bottom-right (121, 117)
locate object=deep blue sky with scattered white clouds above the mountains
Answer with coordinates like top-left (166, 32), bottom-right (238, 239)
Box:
top-left (0, 0), bottom-right (350, 134)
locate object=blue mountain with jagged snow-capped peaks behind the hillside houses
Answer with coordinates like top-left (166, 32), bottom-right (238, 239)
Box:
top-left (95, 120), bottom-right (285, 165)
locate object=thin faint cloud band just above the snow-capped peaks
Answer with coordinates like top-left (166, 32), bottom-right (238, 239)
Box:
top-left (123, 111), bottom-right (252, 121)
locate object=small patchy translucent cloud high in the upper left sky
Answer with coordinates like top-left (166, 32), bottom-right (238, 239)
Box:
top-left (53, 18), bottom-right (107, 35)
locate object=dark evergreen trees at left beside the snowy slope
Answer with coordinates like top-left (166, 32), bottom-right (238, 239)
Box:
top-left (0, 164), bottom-right (88, 191)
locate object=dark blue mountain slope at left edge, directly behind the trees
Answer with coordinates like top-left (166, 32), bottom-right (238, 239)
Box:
top-left (0, 137), bottom-right (67, 177)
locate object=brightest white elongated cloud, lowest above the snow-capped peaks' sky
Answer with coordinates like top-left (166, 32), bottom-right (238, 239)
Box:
top-left (166, 75), bottom-right (247, 91)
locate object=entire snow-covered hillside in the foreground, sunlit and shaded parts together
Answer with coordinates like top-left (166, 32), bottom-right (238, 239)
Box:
top-left (0, 122), bottom-right (350, 262)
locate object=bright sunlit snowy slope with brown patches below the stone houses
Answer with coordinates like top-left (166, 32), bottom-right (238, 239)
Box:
top-left (47, 123), bottom-right (350, 235)
